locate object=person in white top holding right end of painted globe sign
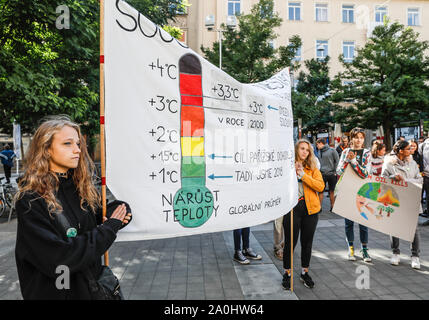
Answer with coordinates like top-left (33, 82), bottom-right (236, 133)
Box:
top-left (382, 140), bottom-right (423, 269)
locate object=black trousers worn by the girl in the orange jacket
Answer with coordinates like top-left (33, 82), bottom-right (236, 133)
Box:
top-left (283, 200), bottom-right (319, 269)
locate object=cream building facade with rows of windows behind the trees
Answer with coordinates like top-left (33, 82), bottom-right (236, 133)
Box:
top-left (177, 0), bottom-right (429, 75)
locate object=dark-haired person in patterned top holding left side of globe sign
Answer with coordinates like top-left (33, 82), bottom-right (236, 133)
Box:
top-left (337, 127), bottom-right (372, 262)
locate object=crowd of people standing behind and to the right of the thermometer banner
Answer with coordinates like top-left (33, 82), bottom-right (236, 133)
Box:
top-left (234, 128), bottom-right (429, 290)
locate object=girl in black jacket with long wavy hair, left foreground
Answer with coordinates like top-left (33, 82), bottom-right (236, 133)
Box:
top-left (15, 117), bottom-right (131, 300)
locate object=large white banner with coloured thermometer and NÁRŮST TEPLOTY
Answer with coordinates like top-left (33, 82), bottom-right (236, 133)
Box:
top-left (104, 0), bottom-right (298, 240)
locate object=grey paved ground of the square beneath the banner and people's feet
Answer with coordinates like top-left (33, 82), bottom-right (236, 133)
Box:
top-left (0, 188), bottom-right (429, 300)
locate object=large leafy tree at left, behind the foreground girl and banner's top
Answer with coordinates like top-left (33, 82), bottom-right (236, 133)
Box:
top-left (0, 0), bottom-right (185, 149)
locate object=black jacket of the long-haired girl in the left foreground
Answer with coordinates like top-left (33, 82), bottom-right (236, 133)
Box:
top-left (15, 178), bottom-right (131, 300)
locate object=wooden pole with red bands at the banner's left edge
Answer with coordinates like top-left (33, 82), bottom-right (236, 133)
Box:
top-left (100, 0), bottom-right (109, 266)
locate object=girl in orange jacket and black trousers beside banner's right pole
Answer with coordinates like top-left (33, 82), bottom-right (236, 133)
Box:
top-left (282, 139), bottom-right (325, 290)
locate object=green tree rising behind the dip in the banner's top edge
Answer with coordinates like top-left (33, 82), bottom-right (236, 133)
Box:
top-left (201, 0), bottom-right (301, 83)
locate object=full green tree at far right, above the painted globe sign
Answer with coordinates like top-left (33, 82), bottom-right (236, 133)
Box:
top-left (332, 21), bottom-right (429, 148)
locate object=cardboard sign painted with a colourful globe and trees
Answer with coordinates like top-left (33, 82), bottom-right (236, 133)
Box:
top-left (332, 166), bottom-right (421, 241)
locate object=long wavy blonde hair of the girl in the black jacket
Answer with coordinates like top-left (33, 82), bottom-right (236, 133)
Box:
top-left (16, 116), bottom-right (101, 214)
